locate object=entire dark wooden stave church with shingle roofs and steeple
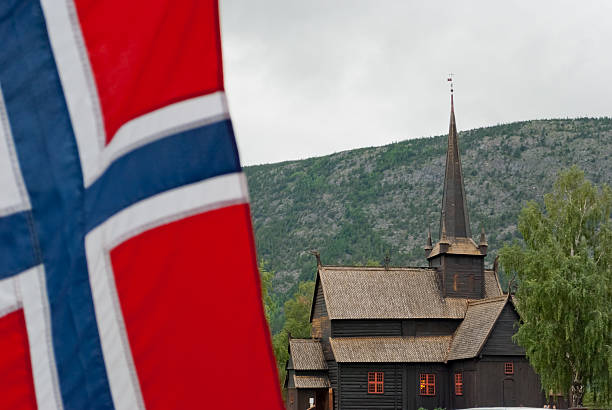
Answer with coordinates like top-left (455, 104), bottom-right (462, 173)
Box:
top-left (284, 94), bottom-right (545, 410)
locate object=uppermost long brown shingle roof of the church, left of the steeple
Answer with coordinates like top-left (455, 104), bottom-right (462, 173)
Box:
top-left (319, 266), bottom-right (467, 319)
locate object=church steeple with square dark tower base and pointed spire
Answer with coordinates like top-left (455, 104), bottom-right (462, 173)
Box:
top-left (426, 84), bottom-right (487, 299)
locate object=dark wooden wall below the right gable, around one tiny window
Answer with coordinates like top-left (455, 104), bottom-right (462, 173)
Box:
top-left (475, 356), bottom-right (544, 407)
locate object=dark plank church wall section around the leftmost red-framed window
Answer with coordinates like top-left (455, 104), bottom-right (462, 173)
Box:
top-left (338, 363), bottom-right (402, 410)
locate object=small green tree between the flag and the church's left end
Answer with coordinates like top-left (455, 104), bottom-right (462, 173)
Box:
top-left (272, 281), bottom-right (314, 383)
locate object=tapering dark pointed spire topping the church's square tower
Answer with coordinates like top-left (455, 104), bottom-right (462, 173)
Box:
top-left (440, 88), bottom-right (472, 240)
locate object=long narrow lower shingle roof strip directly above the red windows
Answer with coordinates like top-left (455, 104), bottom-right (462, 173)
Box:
top-left (329, 336), bottom-right (452, 363)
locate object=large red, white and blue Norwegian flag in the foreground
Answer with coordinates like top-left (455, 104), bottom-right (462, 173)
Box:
top-left (0, 0), bottom-right (282, 409)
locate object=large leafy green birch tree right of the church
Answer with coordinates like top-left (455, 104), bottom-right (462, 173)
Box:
top-left (500, 166), bottom-right (612, 406)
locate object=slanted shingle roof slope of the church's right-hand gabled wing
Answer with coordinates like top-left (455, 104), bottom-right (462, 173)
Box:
top-left (448, 296), bottom-right (508, 360)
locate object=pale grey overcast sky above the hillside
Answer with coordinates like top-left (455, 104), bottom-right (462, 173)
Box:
top-left (220, 0), bottom-right (612, 165)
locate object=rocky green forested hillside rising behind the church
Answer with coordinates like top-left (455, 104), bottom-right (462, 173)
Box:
top-left (245, 118), bottom-right (612, 330)
